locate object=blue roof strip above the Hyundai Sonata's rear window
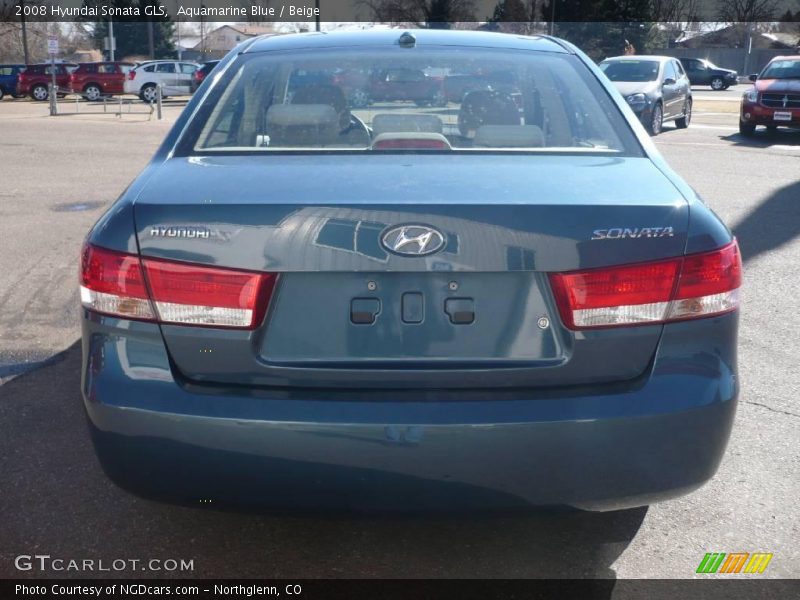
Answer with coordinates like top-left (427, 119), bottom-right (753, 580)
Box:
top-left (245, 29), bottom-right (570, 53)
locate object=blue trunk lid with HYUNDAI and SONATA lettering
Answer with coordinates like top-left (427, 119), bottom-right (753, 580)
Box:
top-left (135, 154), bottom-right (688, 388)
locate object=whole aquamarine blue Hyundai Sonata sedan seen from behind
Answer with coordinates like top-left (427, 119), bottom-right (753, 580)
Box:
top-left (81, 31), bottom-right (741, 510)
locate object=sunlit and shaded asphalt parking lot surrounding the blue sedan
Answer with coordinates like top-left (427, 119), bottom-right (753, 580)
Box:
top-left (0, 98), bottom-right (800, 578)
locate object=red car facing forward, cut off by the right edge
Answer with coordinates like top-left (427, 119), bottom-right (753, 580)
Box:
top-left (739, 55), bottom-right (800, 136)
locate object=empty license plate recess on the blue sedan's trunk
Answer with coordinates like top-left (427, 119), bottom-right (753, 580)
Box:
top-left (260, 272), bottom-right (565, 369)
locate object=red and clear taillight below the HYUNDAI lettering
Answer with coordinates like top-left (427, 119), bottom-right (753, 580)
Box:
top-left (81, 244), bottom-right (277, 329)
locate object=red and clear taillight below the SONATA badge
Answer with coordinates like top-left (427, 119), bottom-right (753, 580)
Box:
top-left (550, 240), bottom-right (742, 329)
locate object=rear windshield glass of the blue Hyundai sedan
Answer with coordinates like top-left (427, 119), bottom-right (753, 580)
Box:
top-left (182, 48), bottom-right (641, 155)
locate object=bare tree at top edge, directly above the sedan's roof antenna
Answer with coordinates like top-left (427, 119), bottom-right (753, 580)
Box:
top-left (356, 0), bottom-right (476, 27)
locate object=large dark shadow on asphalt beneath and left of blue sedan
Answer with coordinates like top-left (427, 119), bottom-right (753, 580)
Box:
top-left (0, 342), bottom-right (647, 584)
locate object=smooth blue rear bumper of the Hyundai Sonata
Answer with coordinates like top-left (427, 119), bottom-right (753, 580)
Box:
top-left (82, 313), bottom-right (738, 510)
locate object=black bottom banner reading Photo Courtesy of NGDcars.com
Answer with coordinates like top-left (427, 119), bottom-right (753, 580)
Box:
top-left (0, 578), bottom-right (800, 600)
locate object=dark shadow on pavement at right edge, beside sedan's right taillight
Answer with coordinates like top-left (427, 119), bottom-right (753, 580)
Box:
top-left (733, 181), bottom-right (800, 262)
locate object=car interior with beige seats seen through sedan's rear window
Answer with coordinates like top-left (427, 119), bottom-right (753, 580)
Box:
top-left (196, 51), bottom-right (622, 151)
